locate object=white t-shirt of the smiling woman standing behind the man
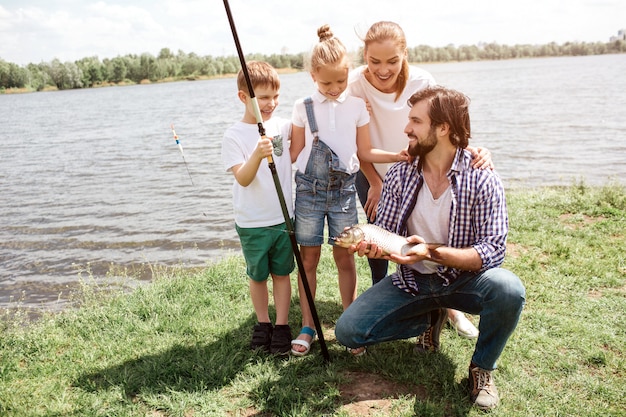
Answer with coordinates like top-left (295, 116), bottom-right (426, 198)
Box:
top-left (348, 65), bottom-right (436, 178)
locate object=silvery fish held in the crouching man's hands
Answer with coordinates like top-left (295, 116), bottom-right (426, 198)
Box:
top-left (334, 224), bottom-right (432, 256)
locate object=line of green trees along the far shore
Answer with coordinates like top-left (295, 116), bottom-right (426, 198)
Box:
top-left (0, 40), bottom-right (626, 93)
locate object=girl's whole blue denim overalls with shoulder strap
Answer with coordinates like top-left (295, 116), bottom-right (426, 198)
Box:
top-left (295, 97), bottom-right (358, 246)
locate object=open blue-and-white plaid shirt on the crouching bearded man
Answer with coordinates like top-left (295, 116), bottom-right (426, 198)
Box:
top-left (376, 149), bottom-right (509, 293)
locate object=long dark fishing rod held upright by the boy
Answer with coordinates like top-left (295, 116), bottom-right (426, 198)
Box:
top-left (224, 0), bottom-right (330, 362)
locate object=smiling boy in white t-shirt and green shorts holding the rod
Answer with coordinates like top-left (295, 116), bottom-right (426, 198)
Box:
top-left (222, 61), bottom-right (295, 355)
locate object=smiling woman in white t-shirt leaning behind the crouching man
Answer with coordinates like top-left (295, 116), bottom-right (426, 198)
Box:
top-left (348, 21), bottom-right (482, 339)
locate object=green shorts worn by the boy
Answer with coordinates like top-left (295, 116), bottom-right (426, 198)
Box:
top-left (235, 223), bottom-right (295, 282)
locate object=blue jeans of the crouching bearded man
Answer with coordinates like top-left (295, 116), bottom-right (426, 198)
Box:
top-left (335, 268), bottom-right (526, 371)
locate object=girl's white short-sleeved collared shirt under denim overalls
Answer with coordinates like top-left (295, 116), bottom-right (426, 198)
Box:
top-left (291, 91), bottom-right (370, 174)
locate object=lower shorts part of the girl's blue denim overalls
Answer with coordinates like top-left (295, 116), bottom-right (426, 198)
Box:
top-left (295, 172), bottom-right (358, 246)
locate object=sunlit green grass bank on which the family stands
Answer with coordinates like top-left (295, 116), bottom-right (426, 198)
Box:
top-left (0, 184), bottom-right (626, 417)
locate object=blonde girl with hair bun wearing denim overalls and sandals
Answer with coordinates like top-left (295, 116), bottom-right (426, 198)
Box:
top-left (290, 25), bottom-right (408, 356)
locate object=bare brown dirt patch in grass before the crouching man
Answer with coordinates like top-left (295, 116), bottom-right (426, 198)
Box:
top-left (339, 372), bottom-right (426, 417)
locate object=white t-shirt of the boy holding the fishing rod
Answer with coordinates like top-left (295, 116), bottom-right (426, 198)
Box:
top-left (222, 117), bottom-right (293, 227)
